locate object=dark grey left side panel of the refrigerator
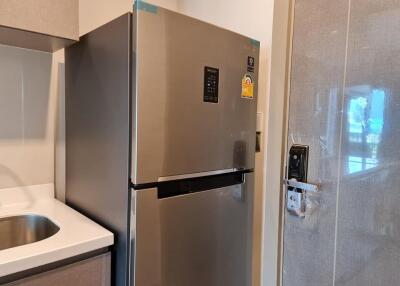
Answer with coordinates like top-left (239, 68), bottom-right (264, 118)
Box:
top-left (65, 14), bottom-right (131, 286)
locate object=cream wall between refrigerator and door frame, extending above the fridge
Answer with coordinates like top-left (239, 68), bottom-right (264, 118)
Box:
top-left (178, 0), bottom-right (274, 286)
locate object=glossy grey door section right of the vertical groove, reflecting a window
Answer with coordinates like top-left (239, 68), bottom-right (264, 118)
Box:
top-left (335, 0), bottom-right (400, 286)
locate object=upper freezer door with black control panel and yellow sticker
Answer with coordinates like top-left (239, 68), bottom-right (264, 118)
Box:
top-left (132, 8), bottom-right (259, 184)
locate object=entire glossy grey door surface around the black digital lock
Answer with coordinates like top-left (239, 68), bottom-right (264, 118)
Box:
top-left (283, 0), bottom-right (400, 286)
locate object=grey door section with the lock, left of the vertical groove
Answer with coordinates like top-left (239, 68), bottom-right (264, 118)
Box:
top-left (283, 0), bottom-right (348, 286)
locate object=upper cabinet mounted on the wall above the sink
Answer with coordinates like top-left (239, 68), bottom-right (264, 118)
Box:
top-left (0, 0), bottom-right (79, 52)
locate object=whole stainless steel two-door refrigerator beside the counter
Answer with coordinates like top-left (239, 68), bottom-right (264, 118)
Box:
top-left (65, 2), bottom-right (259, 286)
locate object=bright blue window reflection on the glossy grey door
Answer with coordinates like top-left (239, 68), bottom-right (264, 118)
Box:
top-left (347, 86), bottom-right (385, 174)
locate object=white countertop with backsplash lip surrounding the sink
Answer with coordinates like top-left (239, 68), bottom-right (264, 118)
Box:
top-left (0, 184), bottom-right (114, 277)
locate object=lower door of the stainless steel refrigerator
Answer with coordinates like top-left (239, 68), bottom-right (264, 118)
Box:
top-left (131, 174), bottom-right (253, 286)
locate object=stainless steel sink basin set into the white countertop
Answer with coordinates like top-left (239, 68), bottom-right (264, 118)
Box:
top-left (0, 215), bottom-right (60, 250)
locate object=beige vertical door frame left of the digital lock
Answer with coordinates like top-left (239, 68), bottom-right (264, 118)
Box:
top-left (262, 0), bottom-right (294, 286)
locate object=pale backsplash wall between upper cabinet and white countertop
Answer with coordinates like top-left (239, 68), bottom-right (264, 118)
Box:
top-left (0, 46), bottom-right (59, 191)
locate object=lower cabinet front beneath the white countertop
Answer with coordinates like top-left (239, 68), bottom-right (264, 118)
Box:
top-left (4, 252), bottom-right (111, 286)
